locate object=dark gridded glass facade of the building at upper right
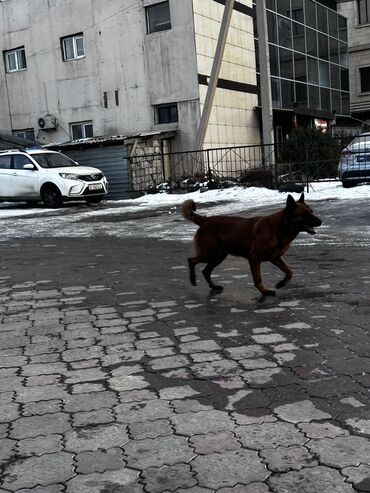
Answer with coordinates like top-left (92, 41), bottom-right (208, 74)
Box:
top-left (257, 0), bottom-right (350, 116)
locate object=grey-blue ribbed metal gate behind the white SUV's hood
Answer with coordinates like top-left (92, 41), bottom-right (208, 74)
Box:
top-left (62, 145), bottom-right (132, 200)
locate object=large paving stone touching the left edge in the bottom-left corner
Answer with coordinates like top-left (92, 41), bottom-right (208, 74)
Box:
top-left (3, 452), bottom-right (75, 491)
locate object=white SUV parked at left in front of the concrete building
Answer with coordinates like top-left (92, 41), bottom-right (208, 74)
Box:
top-left (0, 149), bottom-right (108, 208)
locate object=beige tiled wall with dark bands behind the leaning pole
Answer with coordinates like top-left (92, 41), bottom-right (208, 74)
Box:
top-left (193, 0), bottom-right (260, 148)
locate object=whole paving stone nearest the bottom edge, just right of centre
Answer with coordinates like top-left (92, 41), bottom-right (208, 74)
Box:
top-left (191, 449), bottom-right (268, 489)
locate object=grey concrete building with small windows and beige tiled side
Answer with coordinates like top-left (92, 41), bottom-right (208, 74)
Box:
top-left (0, 0), bottom-right (260, 151)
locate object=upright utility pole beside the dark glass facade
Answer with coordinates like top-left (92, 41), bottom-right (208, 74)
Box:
top-left (256, 0), bottom-right (274, 165)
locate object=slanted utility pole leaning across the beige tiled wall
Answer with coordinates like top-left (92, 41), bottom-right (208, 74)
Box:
top-left (194, 0), bottom-right (234, 150)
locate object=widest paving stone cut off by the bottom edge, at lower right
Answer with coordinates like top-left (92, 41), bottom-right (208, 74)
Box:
top-left (269, 466), bottom-right (353, 493)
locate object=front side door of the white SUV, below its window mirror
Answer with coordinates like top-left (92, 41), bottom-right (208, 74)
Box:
top-left (11, 154), bottom-right (40, 199)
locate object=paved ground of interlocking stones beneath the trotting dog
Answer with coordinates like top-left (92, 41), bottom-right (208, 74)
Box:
top-left (0, 197), bottom-right (370, 493)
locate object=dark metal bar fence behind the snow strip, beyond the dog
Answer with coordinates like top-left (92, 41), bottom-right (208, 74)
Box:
top-left (131, 137), bottom-right (353, 192)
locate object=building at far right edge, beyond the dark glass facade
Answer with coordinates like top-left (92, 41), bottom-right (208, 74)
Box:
top-left (338, 0), bottom-right (370, 127)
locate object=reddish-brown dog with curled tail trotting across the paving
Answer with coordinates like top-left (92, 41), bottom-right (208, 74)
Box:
top-left (181, 193), bottom-right (322, 296)
